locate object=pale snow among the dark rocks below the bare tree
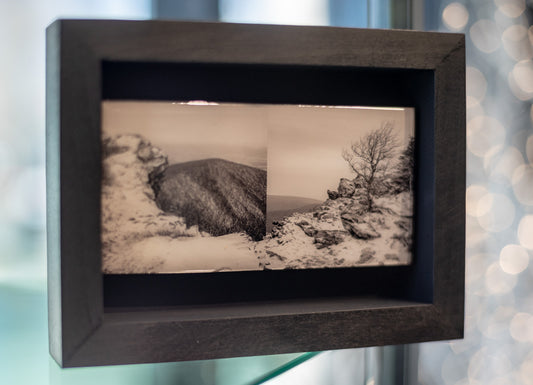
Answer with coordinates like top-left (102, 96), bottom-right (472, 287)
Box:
top-left (261, 193), bottom-right (412, 269)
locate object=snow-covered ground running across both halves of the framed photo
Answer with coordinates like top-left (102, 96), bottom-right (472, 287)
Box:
top-left (102, 135), bottom-right (412, 274)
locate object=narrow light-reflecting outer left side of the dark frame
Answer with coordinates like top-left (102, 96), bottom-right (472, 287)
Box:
top-left (46, 21), bottom-right (63, 365)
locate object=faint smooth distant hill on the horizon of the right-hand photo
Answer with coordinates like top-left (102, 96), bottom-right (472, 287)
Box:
top-left (266, 195), bottom-right (324, 233)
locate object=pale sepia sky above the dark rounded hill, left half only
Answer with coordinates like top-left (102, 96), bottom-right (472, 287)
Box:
top-left (102, 101), bottom-right (267, 170)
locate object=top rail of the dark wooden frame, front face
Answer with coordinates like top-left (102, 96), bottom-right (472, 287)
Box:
top-left (60, 20), bottom-right (457, 70)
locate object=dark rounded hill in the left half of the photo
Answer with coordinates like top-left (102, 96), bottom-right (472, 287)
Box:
top-left (153, 159), bottom-right (266, 240)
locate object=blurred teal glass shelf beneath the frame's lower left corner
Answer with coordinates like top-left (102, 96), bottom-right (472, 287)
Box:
top-left (0, 277), bottom-right (317, 385)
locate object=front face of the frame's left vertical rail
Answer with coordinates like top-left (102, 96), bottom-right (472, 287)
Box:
top-left (59, 21), bottom-right (103, 366)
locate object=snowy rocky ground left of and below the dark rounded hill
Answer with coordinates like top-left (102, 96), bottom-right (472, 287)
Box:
top-left (102, 135), bottom-right (260, 274)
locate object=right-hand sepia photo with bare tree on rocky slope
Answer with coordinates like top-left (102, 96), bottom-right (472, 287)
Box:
top-left (264, 106), bottom-right (414, 269)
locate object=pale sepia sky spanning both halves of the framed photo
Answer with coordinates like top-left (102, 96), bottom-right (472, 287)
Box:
top-left (102, 101), bottom-right (414, 200)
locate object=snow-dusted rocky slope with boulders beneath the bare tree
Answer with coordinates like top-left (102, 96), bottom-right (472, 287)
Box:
top-left (261, 174), bottom-right (413, 269)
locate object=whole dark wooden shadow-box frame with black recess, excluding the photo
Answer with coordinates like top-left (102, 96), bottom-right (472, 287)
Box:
top-left (46, 20), bottom-right (465, 367)
